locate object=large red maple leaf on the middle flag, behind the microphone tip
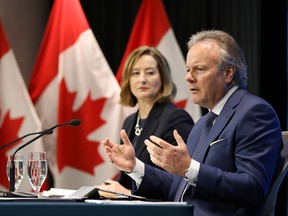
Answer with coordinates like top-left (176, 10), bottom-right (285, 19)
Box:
top-left (57, 80), bottom-right (106, 175)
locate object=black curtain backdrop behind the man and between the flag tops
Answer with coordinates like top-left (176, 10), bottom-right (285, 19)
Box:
top-left (80, 0), bottom-right (287, 130)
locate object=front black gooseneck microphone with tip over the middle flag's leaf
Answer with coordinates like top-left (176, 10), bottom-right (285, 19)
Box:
top-left (10, 119), bottom-right (81, 192)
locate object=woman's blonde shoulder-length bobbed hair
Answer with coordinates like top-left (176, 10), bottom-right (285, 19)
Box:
top-left (120, 46), bottom-right (176, 107)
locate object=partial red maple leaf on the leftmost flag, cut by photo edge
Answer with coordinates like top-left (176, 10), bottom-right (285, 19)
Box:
top-left (0, 110), bottom-right (24, 188)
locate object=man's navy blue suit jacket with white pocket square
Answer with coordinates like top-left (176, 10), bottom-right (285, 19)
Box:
top-left (134, 89), bottom-right (283, 216)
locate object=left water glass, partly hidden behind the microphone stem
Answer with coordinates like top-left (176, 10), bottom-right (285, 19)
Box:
top-left (6, 154), bottom-right (24, 191)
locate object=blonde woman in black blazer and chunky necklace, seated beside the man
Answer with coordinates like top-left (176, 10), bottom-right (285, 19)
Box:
top-left (99, 46), bottom-right (194, 194)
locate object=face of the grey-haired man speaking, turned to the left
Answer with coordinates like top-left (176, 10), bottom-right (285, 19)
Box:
top-left (185, 41), bottom-right (231, 109)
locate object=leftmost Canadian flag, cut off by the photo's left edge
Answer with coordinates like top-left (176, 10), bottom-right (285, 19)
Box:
top-left (0, 22), bottom-right (43, 191)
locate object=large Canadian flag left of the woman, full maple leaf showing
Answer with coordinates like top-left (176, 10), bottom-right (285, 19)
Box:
top-left (29, 0), bottom-right (131, 189)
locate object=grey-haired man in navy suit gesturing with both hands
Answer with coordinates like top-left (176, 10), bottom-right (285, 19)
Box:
top-left (103, 30), bottom-right (283, 216)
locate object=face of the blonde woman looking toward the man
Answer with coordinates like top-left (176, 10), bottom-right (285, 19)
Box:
top-left (129, 55), bottom-right (162, 103)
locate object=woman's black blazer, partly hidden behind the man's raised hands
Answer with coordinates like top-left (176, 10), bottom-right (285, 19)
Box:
top-left (118, 103), bottom-right (194, 189)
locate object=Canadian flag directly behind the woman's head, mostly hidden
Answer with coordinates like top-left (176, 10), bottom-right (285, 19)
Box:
top-left (116, 0), bottom-right (201, 122)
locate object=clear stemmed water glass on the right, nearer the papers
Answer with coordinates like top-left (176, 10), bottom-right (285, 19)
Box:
top-left (27, 152), bottom-right (47, 196)
